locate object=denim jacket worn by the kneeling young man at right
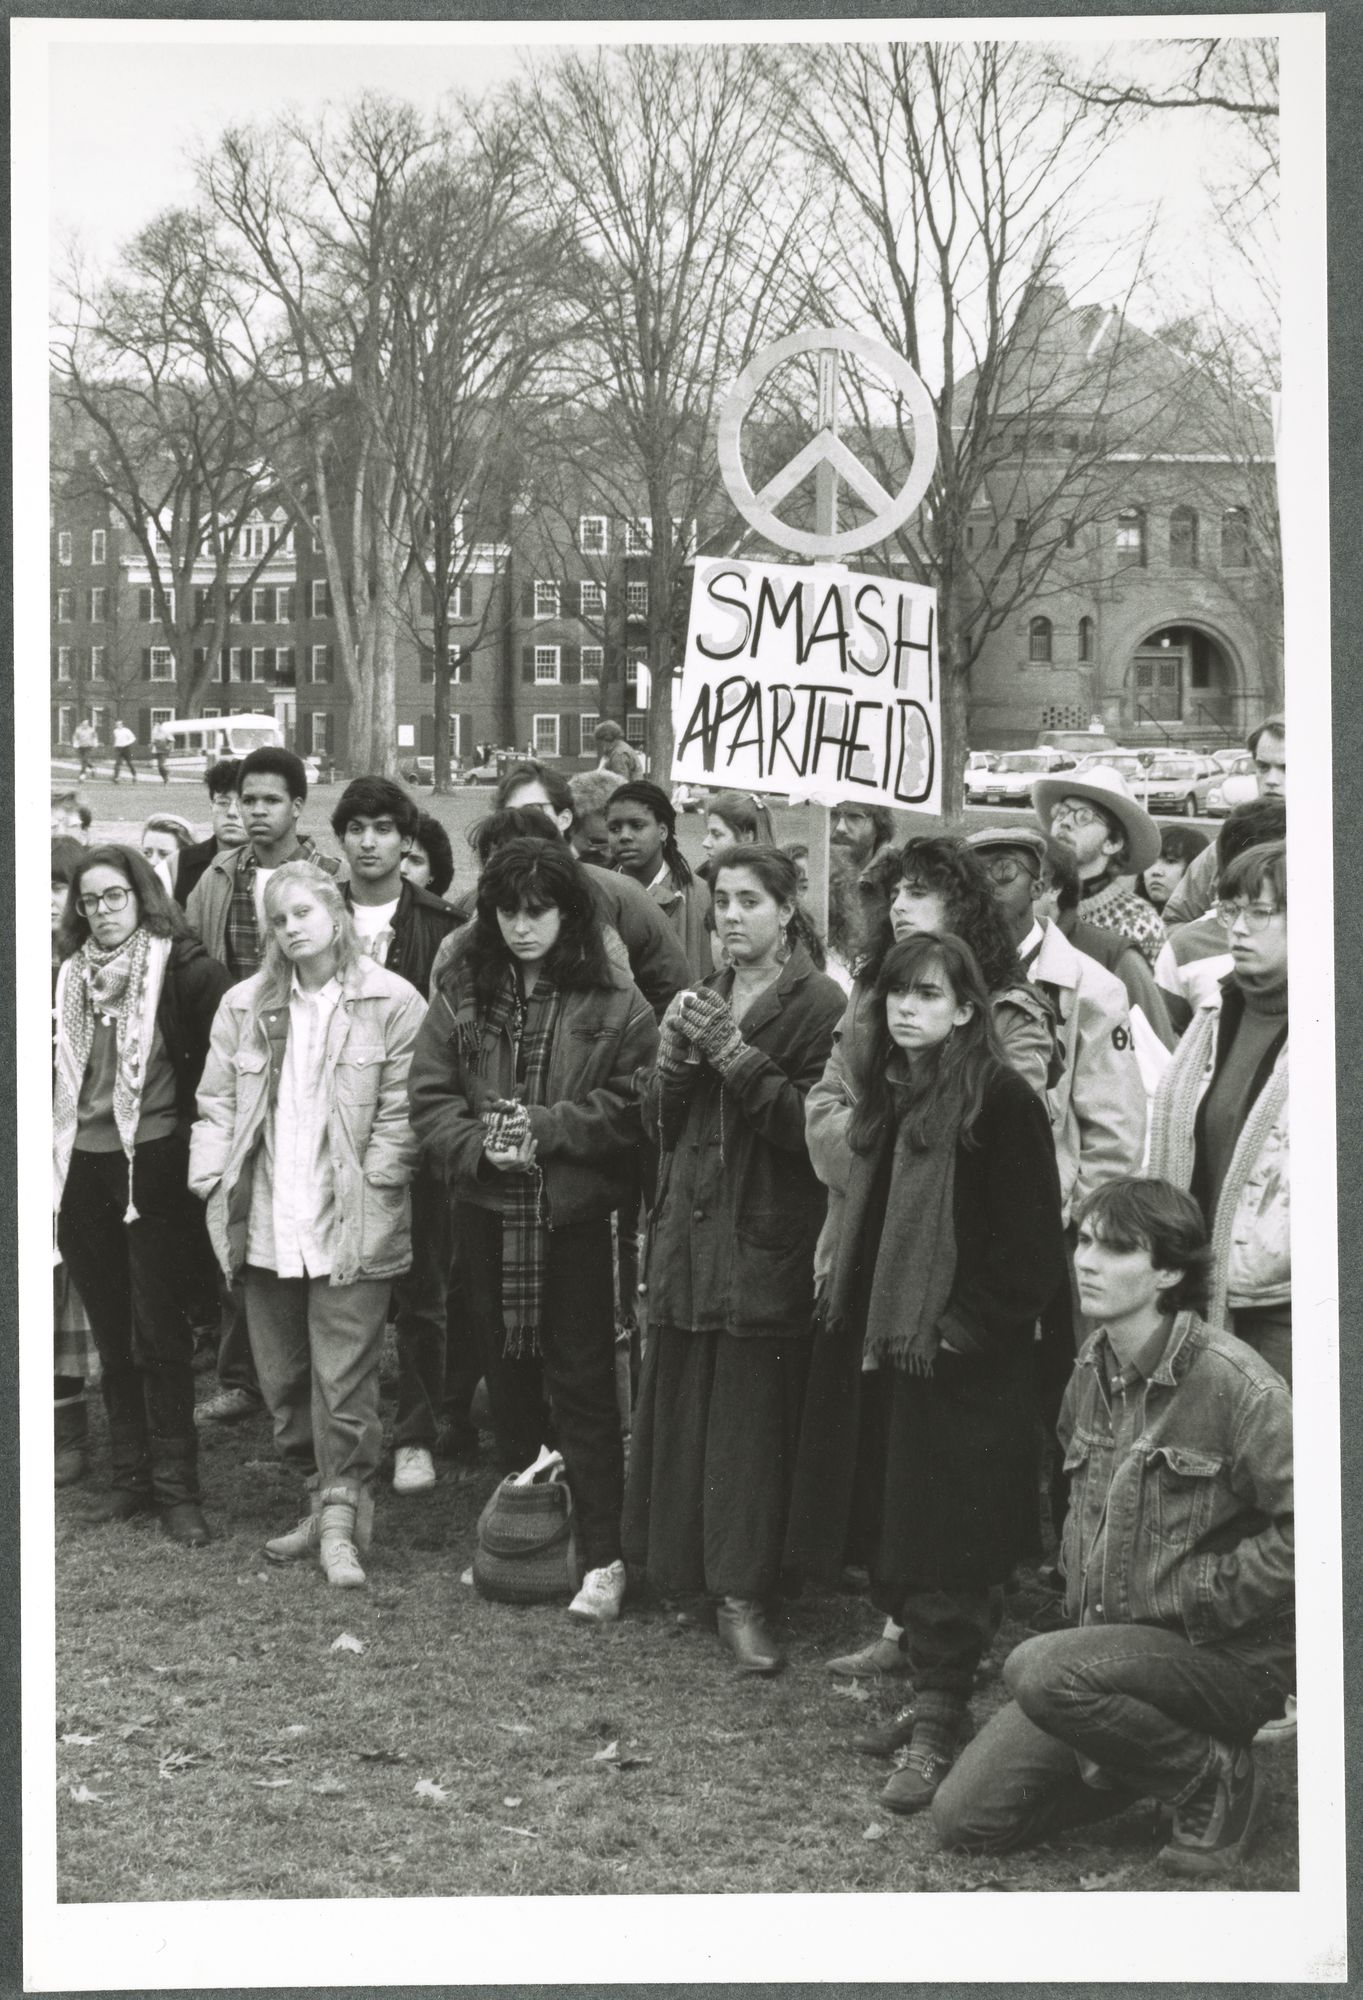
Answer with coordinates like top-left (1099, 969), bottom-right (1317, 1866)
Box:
top-left (1059, 1312), bottom-right (1295, 1646)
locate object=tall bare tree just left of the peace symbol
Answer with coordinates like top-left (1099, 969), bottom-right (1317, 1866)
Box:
top-left (518, 44), bottom-right (807, 782)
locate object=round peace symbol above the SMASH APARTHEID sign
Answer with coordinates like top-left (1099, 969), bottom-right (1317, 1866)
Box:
top-left (717, 326), bottom-right (937, 558)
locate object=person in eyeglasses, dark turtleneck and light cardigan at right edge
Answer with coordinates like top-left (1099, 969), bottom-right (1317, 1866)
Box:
top-left (1149, 840), bottom-right (1291, 1384)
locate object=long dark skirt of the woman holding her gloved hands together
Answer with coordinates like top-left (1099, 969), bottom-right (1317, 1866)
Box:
top-left (624, 1326), bottom-right (809, 1598)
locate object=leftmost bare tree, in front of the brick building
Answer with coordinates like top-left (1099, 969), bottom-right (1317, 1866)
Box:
top-left (50, 210), bottom-right (292, 716)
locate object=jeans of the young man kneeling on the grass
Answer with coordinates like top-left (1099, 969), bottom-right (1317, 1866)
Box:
top-left (933, 1626), bottom-right (1295, 1852)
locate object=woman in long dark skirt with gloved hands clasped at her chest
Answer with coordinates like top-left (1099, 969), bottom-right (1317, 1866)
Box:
top-left (626, 846), bottom-right (843, 1674)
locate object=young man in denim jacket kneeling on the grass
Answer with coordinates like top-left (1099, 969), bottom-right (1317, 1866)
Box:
top-left (931, 1180), bottom-right (1295, 1876)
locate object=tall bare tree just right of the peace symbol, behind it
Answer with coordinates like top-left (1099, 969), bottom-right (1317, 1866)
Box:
top-left (785, 42), bottom-right (1179, 812)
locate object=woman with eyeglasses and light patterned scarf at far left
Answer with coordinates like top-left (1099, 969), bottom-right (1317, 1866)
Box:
top-left (52, 846), bottom-right (228, 1548)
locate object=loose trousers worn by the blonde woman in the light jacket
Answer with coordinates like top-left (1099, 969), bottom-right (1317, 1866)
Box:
top-left (244, 1264), bottom-right (392, 1496)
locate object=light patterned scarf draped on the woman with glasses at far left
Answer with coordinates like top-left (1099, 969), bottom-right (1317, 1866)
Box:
top-left (52, 924), bottom-right (170, 1222)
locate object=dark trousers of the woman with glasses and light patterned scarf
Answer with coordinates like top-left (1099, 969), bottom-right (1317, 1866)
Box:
top-left (56, 1134), bottom-right (194, 1456)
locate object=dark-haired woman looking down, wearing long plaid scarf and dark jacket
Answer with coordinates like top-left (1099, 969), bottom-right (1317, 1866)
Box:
top-left (412, 838), bottom-right (658, 1622)
